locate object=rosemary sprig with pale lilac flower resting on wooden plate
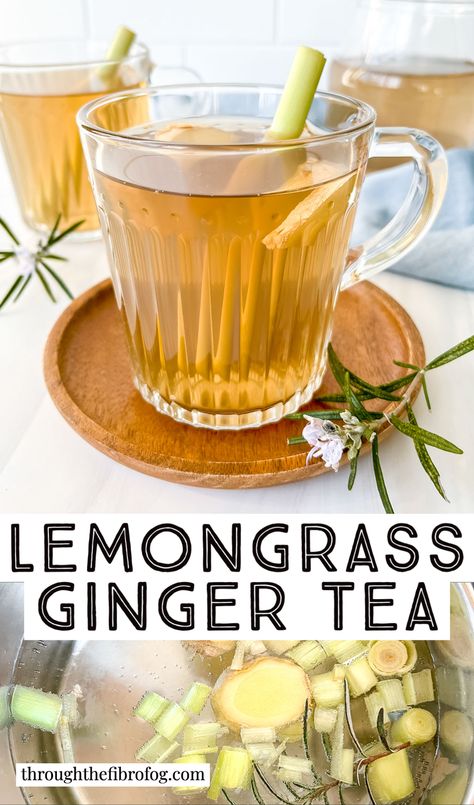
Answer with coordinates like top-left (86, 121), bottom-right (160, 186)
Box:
top-left (288, 336), bottom-right (474, 514)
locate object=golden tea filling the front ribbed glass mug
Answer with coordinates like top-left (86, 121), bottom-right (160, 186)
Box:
top-left (95, 123), bottom-right (359, 427)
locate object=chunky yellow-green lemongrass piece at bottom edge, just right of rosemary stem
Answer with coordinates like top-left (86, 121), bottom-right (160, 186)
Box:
top-left (367, 749), bottom-right (415, 805)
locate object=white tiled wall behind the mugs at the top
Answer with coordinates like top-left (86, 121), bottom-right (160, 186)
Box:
top-left (0, 0), bottom-right (359, 83)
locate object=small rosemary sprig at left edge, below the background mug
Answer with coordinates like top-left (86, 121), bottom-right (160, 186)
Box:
top-left (0, 215), bottom-right (83, 310)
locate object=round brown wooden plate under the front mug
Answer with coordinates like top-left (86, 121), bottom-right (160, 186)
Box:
top-left (45, 280), bottom-right (425, 489)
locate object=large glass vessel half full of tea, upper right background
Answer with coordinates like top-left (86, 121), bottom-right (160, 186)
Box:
top-left (330, 0), bottom-right (474, 148)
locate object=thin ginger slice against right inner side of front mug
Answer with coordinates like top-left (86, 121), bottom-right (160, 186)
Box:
top-left (262, 173), bottom-right (355, 249)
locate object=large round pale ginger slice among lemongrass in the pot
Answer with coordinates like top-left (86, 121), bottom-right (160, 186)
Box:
top-left (211, 657), bottom-right (311, 732)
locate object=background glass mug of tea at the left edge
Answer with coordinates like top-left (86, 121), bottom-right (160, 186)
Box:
top-left (0, 39), bottom-right (150, 237)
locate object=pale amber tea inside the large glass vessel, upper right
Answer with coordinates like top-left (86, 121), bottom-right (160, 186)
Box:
top-left (330, 57), bottom-right (474, 152)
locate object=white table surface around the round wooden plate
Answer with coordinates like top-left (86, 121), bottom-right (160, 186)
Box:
top-left (0, 153), bottom-right (474, 516)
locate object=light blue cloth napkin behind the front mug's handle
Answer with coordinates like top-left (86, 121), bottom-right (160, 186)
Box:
top-left (353, 148), bottom-right (474, 290)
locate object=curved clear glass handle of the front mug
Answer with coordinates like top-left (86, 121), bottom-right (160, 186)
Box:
top-left (341, 128), bottom-right (448, 289)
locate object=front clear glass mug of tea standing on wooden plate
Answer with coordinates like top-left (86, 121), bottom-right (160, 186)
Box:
top-left (78, 85), bottom-right (447, 430)
